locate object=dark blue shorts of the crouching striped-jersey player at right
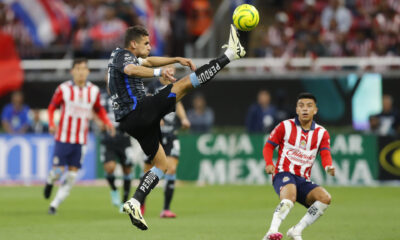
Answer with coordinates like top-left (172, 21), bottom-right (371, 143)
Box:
top-left (272, 172), bottom-right (319, 208)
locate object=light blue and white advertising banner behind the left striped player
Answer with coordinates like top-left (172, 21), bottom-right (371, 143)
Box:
top-left (0, 134), bottom-right (96, 183)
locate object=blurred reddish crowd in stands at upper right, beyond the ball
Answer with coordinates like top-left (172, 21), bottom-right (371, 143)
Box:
top-left (254, 0), bottom-right (400, 58)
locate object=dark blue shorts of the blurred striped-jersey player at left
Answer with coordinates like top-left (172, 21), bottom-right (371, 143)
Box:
top-left (53, 141), bottom-right (84, 168)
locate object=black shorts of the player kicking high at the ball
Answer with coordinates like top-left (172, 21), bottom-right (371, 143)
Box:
top-left (120, 84), bottom-right (176, 160)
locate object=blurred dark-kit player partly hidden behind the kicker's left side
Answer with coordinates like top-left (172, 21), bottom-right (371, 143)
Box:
top-left (100, 89), bottom-right (132, 207)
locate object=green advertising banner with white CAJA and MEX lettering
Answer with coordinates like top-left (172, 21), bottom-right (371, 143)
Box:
top-left (178, 134), bottom-right (378, 185)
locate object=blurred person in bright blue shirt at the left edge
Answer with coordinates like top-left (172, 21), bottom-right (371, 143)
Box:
top-left (1, 91), bottom-right (29, 134)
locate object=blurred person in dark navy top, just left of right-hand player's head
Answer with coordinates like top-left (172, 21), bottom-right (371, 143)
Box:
top-left (246, 90), bottom-right (277, 133)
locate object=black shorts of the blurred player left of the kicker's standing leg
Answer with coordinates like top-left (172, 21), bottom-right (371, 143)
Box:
top-left (100, 134), bottom-right (132, 167)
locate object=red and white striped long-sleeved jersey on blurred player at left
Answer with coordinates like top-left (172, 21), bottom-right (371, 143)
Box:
top-left (48, 81), bottom-right (111, 144)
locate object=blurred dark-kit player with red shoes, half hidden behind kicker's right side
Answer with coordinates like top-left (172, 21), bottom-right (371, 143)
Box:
top-left (141, 65), bottom-right (190, 218)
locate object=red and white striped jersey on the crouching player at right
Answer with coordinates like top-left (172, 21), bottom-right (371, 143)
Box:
top-left (268, 118), bottom-right (330, 179)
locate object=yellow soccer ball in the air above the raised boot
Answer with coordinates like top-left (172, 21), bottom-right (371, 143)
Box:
top-left (232, 4), bottom-right (260, 31)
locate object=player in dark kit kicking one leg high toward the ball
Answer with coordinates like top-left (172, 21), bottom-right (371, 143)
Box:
top-left (108, 25), bottom-right (246, 230)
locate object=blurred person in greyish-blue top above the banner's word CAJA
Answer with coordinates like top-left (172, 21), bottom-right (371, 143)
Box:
top-left (187, 93), bottom-right (214, 133)
